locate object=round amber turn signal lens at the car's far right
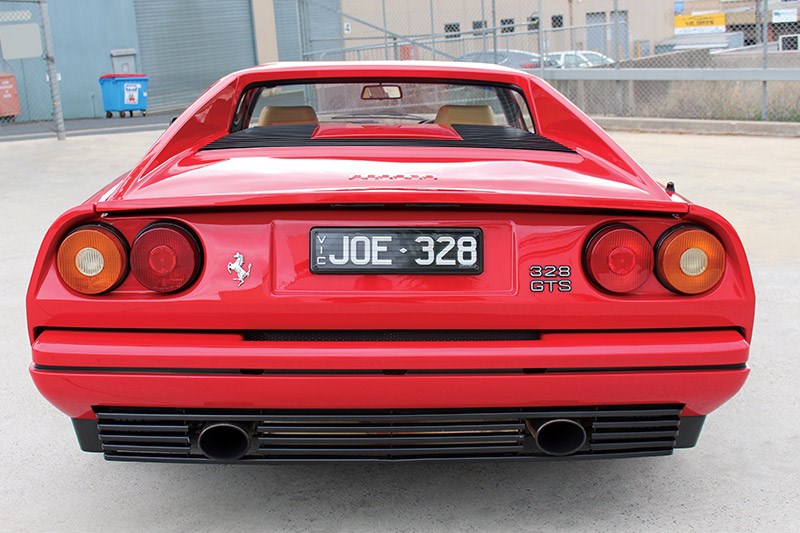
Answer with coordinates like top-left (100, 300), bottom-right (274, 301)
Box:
top-left (656, 226), bottom-right (725, 294)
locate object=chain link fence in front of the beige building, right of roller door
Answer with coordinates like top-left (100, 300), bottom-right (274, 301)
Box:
top-left (299, 0), bottom-right (800, 121)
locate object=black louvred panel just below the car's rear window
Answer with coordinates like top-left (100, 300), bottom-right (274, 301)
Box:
top-left (200, 124), bottom-right (576, 154)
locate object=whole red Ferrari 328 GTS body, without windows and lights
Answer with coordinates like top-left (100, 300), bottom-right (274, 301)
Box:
top-left (27, 62), bottom-right (755, 463)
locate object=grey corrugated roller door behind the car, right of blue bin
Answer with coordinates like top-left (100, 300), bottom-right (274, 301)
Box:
top-left (134, 0), bottom-right (256, 110)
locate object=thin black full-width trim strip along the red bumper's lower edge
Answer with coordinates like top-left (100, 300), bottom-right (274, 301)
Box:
top-left (34, 363), bottom-right (747, 377)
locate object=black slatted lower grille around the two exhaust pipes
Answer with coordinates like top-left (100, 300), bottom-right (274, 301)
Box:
top-left (96, 405), bottom-right (681, 463)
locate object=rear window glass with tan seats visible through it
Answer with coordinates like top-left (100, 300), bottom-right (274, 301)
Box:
top-left (238, 80), bottom-right (534, 133)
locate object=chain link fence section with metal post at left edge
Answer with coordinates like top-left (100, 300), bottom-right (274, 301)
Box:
top-left (0, 0), bottom-right (64, 138)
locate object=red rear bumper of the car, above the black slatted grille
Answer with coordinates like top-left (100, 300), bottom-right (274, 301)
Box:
top-left (31, 330), bottom-right (749, 460)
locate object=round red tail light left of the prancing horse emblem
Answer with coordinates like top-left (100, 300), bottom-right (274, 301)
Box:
top-left (131, 222), bottom-right (201, 293)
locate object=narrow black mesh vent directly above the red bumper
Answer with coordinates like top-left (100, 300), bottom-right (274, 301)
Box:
top-left (243, 329), bottom-right (539, 342)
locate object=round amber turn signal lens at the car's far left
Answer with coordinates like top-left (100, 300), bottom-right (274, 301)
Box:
top-left (56, 225), bottom-right (128, 294)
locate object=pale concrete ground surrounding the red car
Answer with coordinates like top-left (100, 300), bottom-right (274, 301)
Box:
top-left (0, 132), bottom-right (800, 532)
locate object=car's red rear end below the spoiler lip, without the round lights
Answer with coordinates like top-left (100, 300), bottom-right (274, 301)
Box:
top-left (32, 200), bottom-right (750, 461)
